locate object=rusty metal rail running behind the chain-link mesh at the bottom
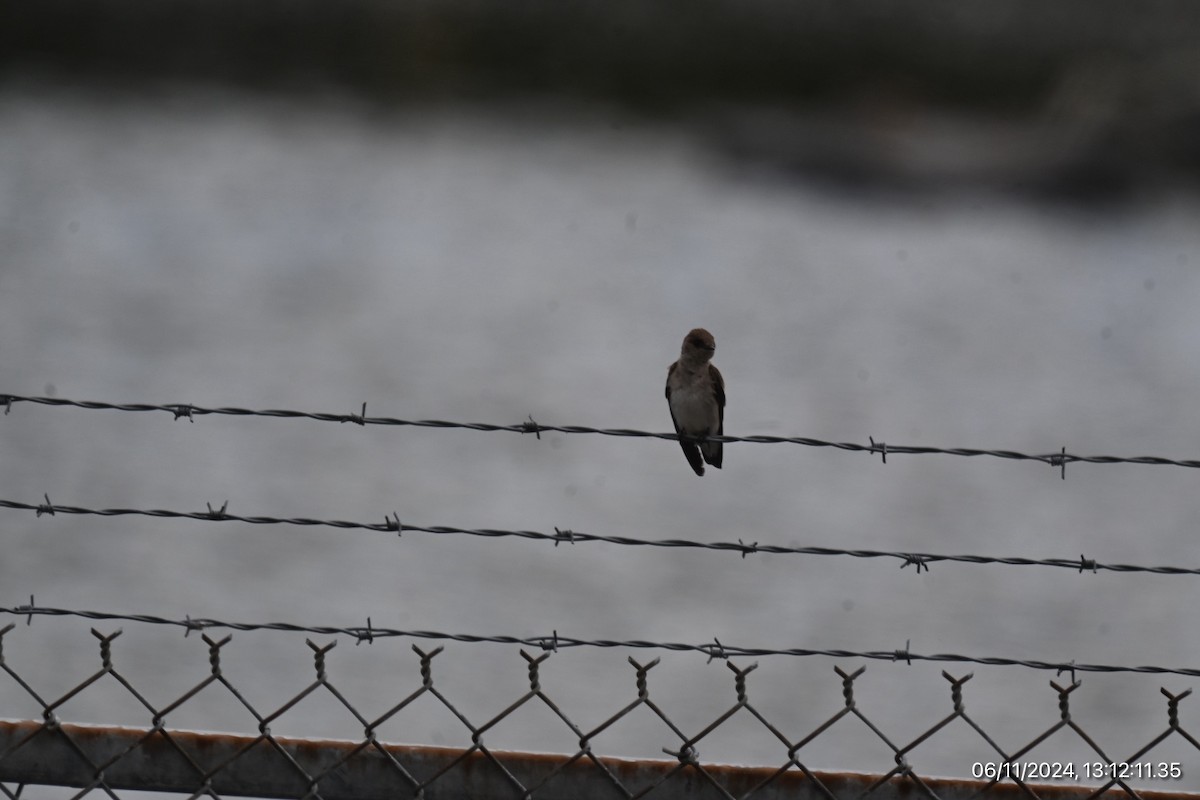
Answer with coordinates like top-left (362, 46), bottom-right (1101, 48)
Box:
top-left (0, 722), bottom-right (1200, 800)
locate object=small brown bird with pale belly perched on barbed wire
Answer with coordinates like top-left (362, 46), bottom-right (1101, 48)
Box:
top-left (667, 327), bottom-right (725, 475)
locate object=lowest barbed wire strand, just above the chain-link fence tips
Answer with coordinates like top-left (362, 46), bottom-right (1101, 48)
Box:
top-left (0, 604), bottom-right (1200, 680)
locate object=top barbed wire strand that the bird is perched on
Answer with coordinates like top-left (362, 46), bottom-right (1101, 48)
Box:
top-left (7, 393), bottom-right (1200, 479)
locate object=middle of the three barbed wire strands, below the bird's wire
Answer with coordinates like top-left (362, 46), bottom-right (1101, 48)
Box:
top-left (0, 495), bottom-right (1200, 575)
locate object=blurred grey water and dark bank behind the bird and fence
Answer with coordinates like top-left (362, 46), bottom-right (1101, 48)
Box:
top-left (0, 0), bottom-right (1200, 789)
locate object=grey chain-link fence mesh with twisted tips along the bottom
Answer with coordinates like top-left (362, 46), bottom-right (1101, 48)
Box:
top-left (0, 607), bottom-right (1200, 800)
